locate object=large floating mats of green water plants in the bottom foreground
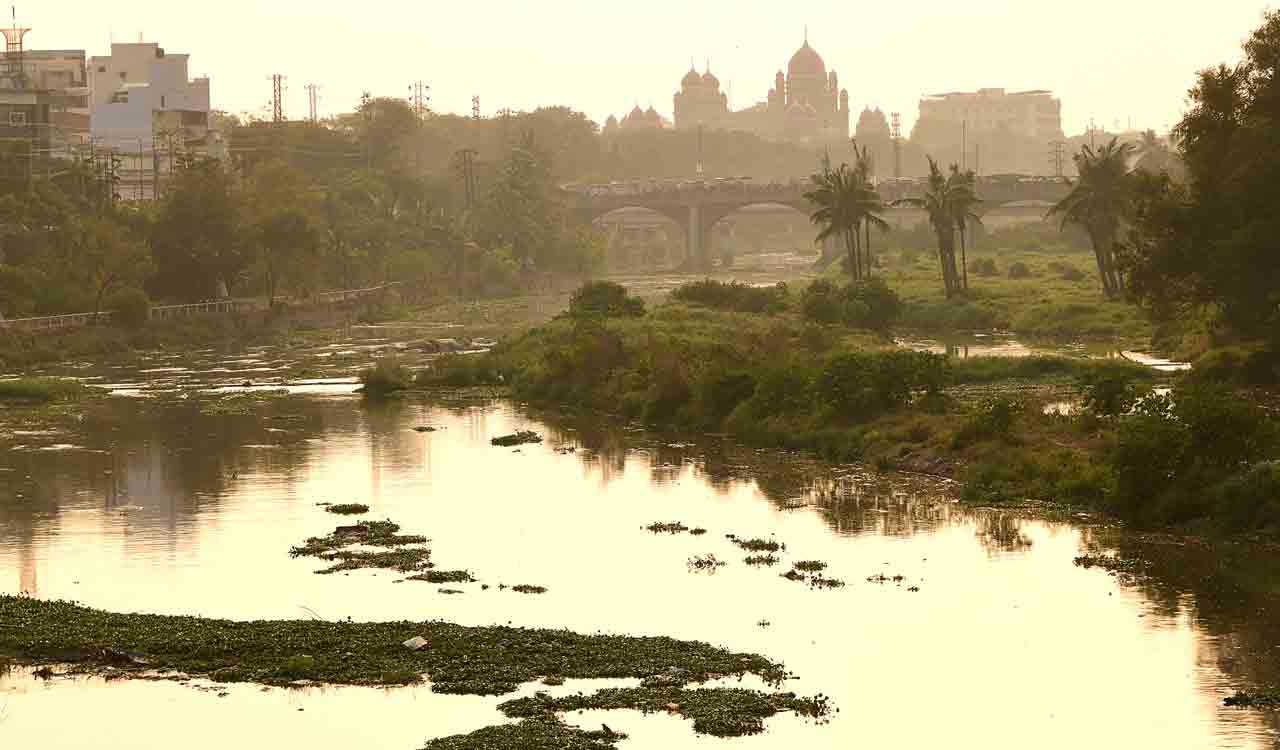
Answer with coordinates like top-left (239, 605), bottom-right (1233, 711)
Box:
top-left (0, 595), bottom-right (831, 749)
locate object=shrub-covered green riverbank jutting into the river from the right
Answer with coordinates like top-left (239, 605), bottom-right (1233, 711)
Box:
top-left (437, 289), bottom-right (1280, 534)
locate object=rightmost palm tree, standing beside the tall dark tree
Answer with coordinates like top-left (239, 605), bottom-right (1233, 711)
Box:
top-left (1048, 138), bottom-right (1133, 298)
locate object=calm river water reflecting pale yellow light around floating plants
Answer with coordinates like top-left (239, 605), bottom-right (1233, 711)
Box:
top-left (0, 342), bottom-right (1264, 750)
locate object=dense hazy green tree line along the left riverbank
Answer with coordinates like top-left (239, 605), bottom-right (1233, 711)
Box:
top-left (0, 100), bottom-right (603, 317)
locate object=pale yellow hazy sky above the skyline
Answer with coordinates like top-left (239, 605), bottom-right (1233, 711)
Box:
top-left (18, 0), bottom-right (1265, 134)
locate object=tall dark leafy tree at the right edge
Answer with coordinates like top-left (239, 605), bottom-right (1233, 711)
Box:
top-left (1123, 12), bottom-right (1280, 335)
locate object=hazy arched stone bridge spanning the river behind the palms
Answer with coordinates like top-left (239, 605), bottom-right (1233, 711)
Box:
top-left (563, 175), bottom-right (1070, 267)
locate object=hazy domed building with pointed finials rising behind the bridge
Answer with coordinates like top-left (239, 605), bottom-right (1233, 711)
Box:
top-left (675, 38), bottom-right (850, 142)
